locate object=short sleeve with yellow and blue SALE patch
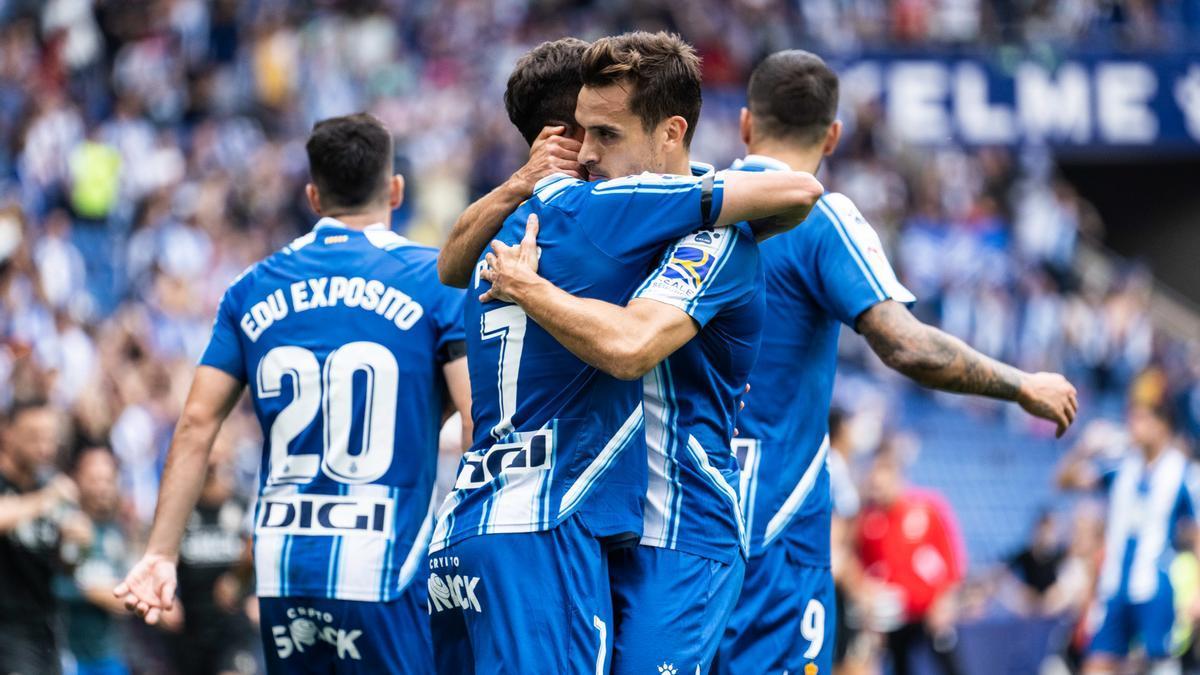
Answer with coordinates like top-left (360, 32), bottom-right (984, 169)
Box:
top-left (634, 226), bottom-right (758, 327)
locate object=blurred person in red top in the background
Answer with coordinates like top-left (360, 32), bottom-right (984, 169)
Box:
top-left (857, 448), bottom-right (966, 675)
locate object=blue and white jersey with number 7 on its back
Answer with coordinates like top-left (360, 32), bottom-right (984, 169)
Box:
top-left (430, 167), bottom-right (724, 551)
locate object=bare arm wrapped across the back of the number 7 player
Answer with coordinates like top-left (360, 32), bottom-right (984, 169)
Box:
top-left (481, 215), bottom-right (700, 380)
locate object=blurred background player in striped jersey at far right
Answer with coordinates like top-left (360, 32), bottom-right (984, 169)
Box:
top-left (1058, 400), bottom-right (1200, 675)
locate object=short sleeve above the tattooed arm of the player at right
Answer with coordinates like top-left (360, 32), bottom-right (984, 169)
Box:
top-left (810, 193), bottom-right (917, 328)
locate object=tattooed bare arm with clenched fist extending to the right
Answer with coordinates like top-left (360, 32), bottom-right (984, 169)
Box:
top-left (854, 300), bottom-right (1079, 437)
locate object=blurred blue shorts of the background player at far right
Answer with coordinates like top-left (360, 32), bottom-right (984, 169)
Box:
top-left (1087, 573), bottom-right (1175, 661)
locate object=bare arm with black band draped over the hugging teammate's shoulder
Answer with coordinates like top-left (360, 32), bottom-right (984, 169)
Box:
top-left (716, 171), bottom-right (824, 230)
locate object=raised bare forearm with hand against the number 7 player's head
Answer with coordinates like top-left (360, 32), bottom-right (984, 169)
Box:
top-left (438, 126), bottom-right (581, 288)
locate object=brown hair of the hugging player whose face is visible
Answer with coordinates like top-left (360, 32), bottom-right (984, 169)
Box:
top-left (583, 31), bottom-right (703, 147)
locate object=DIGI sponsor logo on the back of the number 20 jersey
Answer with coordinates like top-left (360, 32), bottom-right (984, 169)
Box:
top-left (258, 495), bottom-right (395, 537)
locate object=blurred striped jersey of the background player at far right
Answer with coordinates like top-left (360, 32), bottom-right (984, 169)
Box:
top-left (1097, 448), bottom-right (1200, 603)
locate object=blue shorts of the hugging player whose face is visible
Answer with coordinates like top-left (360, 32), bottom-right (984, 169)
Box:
top-left (608, 545), bottom-right (745, 675)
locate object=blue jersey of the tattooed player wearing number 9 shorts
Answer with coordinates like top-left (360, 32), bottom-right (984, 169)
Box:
top-left (733, 155), bottom-right (916, 566)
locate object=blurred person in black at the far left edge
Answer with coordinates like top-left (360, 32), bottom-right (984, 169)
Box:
top-left (0, 400), bottom-right (91, 675)
